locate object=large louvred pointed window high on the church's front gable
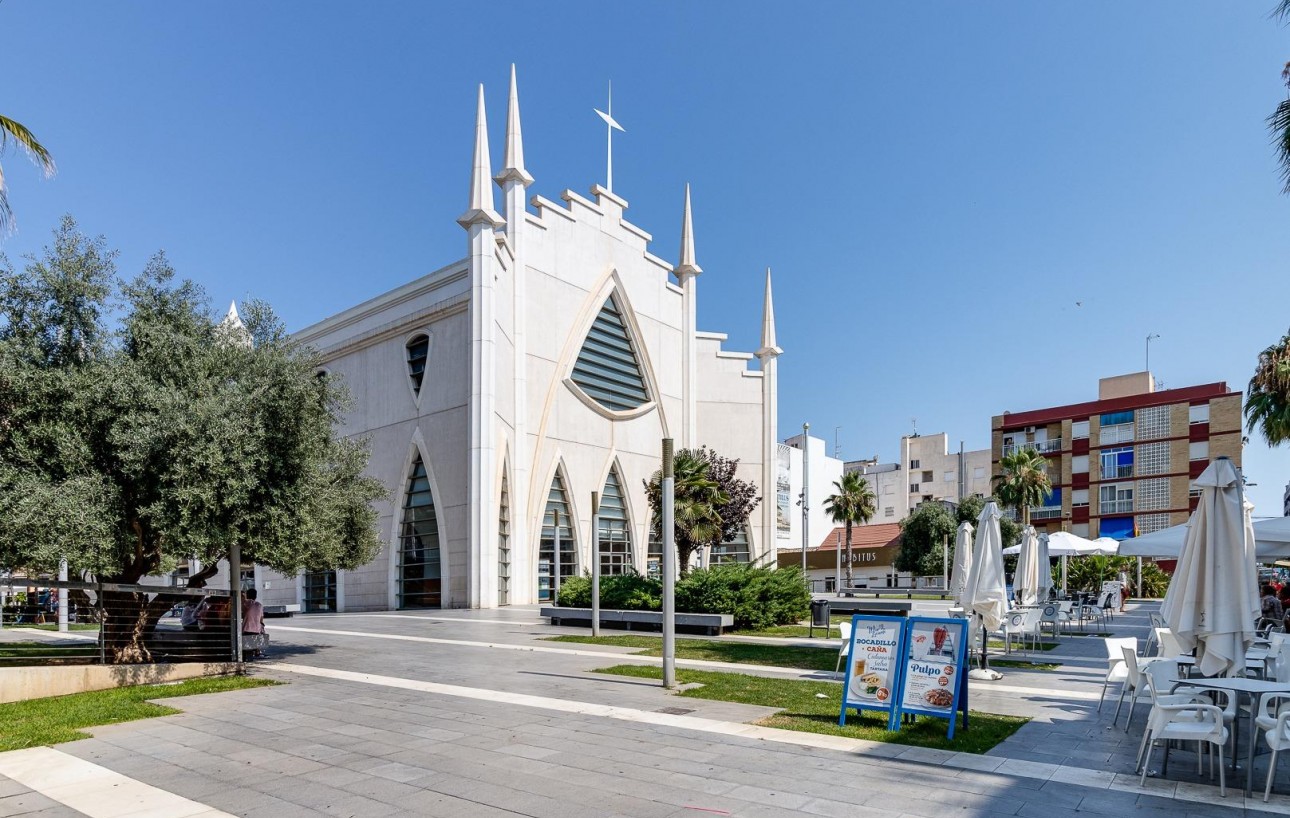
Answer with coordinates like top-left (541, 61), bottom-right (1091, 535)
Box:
top-left (573, 295), bottom-right (650, 412)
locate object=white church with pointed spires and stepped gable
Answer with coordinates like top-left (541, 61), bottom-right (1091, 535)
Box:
top-left (257, 67), bottom-right (782, 612)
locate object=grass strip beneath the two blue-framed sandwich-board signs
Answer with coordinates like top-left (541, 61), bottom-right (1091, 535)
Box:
top-left (593, 664), bottom-right (1029, 753)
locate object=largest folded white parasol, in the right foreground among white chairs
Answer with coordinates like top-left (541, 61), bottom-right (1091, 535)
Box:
top-left (1160, 457), bottom-right (1259, 676)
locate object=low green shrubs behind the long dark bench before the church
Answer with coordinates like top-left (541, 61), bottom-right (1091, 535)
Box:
top-left (556, 565), bottom-right (810, 630)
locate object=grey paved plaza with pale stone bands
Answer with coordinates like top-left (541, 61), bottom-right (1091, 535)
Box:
top-left (0, 603), bottom-right (1290, 818)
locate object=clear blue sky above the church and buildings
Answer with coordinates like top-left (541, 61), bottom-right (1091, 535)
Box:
top-left (0, 0), bottom-right (1290, 514)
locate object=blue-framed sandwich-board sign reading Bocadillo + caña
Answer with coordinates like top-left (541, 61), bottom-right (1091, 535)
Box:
top-left (837, 614), bottom-right (908, 730)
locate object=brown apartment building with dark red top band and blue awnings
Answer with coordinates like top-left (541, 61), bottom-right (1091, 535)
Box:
top-left (991, 372), bottom-right (1241, 539)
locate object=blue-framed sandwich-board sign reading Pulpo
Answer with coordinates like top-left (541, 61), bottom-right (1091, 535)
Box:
top-left (891, 617), bottom-right (968, 738)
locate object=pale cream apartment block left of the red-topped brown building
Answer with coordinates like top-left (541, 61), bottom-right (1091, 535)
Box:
top-left (845, 432), bottom-right (991, 525)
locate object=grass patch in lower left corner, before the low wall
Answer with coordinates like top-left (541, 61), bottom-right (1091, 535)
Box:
top-left (0, 676), bottom-right (279, 752)
